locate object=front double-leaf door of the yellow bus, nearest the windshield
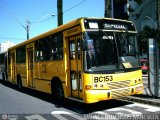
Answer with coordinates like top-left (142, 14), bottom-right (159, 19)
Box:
top-left (69, 35), bottom-right (82, 98)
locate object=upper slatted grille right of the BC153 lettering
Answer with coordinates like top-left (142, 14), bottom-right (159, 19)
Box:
top-left (107, 80), bottom-right (131, 89)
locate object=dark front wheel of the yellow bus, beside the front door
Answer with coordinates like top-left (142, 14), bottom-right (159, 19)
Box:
top-left (52, 80), bottom-right (64, 102)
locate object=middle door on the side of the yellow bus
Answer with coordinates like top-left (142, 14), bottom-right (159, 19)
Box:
top-left (26, 47), bottom-right (34, 87)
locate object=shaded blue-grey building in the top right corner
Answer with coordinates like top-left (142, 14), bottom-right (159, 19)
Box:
top-left (129, 0), bottom-right (160, 31)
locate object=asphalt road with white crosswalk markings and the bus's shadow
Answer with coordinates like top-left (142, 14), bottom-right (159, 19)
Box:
top-left (0, 79), bottom-right (160, 120)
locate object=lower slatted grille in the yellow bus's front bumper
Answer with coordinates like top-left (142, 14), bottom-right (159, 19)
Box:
top-left (111, 88), bottom-right (130, 99)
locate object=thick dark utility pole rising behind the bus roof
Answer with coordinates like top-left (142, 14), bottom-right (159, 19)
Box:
top-left (57, 0), bottom-right (63, 26)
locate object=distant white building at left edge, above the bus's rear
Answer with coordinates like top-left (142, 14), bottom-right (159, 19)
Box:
top-left (0, 41), bottom-right (15, 52)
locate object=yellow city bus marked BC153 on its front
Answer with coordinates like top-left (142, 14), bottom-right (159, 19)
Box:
top-left (7, 18), bottom-right (143, 103)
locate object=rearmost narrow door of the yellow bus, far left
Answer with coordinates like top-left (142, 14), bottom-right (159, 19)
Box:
top-left (10, 51), bottom-right (16, 83)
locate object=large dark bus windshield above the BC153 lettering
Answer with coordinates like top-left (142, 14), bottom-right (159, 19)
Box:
top-left (84, 31), bottom-right (139, 71)
